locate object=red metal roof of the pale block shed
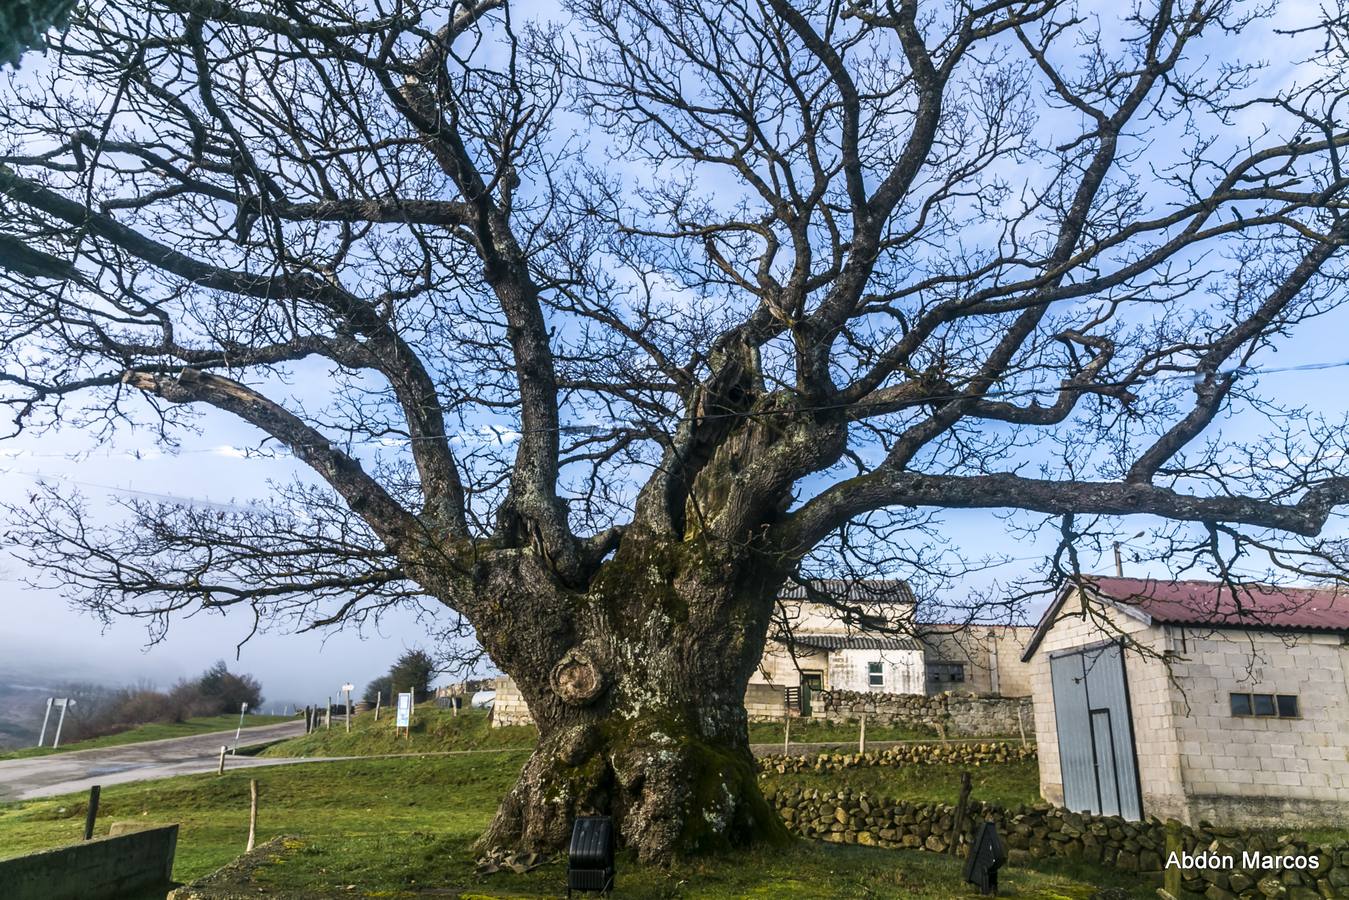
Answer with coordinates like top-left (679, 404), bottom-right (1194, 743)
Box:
top-left (1089, 576), bottom-right (1349, 631)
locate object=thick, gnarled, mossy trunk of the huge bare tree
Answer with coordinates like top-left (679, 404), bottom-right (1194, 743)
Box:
top-left (479, 544), bottom-right (786, 862)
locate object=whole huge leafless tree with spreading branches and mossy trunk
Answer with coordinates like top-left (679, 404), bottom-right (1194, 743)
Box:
top-left (0, 0), bottom-right (1349, 861)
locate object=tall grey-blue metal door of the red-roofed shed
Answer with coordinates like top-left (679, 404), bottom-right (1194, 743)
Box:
top-left (1050, 644), bottom-right (1143, 820)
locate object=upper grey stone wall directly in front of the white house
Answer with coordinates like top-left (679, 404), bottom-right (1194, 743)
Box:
top-left (812, 691), bottom-right (1035, 737)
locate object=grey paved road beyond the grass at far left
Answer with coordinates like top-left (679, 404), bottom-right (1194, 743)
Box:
top-left (0, 719), bottom-right (305, 800)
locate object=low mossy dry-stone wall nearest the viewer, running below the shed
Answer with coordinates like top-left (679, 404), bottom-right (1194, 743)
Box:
top-left (766, 788), bottom-right (1349, 900)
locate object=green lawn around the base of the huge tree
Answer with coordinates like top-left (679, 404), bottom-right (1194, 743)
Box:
top-left (0, 733), bottom-right (1148, 900)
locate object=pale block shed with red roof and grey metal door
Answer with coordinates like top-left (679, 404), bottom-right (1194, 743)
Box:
top-left (1023, 578), bottom-right (1349, 826)
